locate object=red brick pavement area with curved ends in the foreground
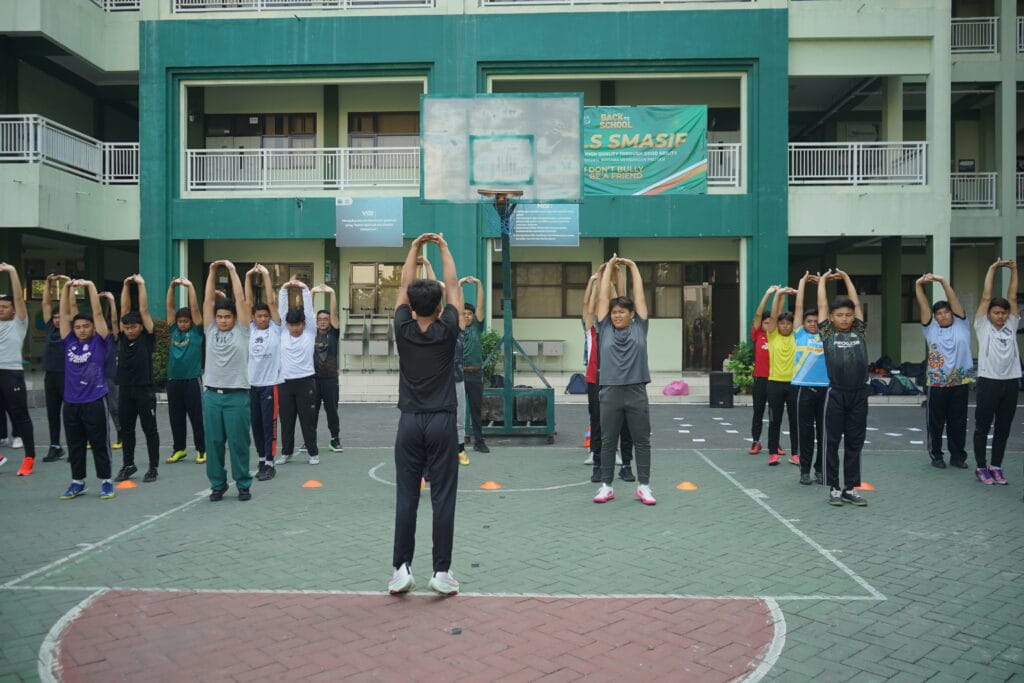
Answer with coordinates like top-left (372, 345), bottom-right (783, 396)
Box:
top-left (51, 591), bottom-right (773, 683)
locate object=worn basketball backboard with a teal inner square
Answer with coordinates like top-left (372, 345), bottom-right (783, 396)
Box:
top-left (420, 93), bottom-right (583, 204)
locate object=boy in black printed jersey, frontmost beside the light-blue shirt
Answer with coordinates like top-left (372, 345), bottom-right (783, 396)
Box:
top-left (818, 269), bottom-right (868, 507)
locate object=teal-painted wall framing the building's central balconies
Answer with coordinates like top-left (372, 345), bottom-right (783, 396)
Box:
top-left (139, 9), bottom-right (788, 313)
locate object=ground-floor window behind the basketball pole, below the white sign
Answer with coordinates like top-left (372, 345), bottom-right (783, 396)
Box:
top-left (492, 263), bottom-right (592, 317)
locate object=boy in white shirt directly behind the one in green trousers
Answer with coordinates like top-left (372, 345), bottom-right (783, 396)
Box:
top-left (246, 263), bottom-right (282, 481)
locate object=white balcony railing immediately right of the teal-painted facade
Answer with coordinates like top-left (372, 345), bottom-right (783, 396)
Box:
top-left (790, 142), bottom-right (928, 185)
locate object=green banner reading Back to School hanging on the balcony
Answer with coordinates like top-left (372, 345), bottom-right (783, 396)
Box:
top-left (583, 104), bottom-right (708, 195)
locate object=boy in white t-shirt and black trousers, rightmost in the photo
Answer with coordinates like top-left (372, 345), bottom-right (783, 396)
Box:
top-left (974, 260), bottom-right (1021, 484)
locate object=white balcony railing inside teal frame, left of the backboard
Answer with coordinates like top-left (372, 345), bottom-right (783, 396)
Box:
top-left (186, 147), bottom-right (420, 190)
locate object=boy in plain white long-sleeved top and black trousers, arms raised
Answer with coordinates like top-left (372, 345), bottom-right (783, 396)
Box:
top-left (275, 280), bottom-right (317, 465)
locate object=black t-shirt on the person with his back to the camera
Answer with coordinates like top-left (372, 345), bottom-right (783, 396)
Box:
top-left (394, 304), bottom-right (459, 413)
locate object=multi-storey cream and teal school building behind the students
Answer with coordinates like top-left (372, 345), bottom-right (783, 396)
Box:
top-left (0, 0), bottom-right (1024, 372)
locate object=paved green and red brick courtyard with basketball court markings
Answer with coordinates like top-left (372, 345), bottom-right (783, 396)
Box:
top-left (0, 401), bottom-right (1024, 682)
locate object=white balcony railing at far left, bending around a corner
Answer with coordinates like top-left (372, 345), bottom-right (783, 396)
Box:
top-left (0, 114), bottom-right (138, 184)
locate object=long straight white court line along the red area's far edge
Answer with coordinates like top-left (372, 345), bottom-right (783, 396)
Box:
top-left (0, 574), bottom-right (878, 602)
